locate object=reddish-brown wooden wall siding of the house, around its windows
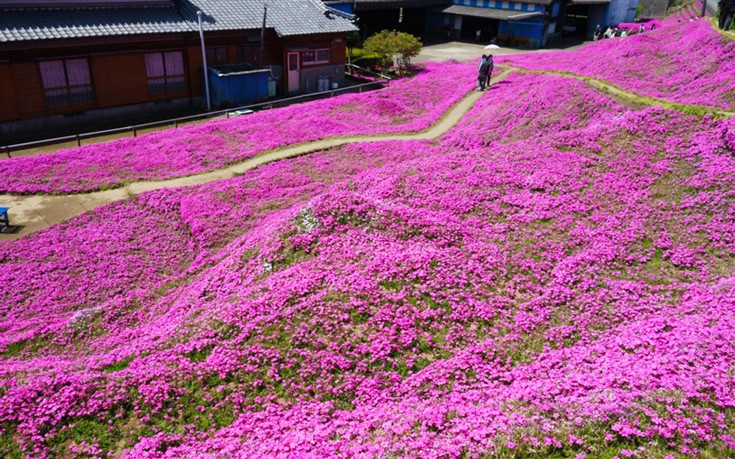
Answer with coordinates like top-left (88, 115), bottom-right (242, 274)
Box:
top-left (0, 29), bottom-right (346, 121)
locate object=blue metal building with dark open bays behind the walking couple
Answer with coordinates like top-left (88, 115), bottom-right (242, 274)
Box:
top-left (324, 0), bottom-right (639, 48)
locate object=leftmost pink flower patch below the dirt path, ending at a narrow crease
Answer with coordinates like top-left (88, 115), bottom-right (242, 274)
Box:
top-left (0, 193), bottom-right (197, 352)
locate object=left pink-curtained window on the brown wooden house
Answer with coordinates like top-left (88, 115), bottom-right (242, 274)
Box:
top-left (38, 57), bottom-right (94, 107)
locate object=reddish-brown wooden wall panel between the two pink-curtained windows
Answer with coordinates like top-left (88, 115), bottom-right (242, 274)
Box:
top-left (90, 53), bottom-right (149, 108)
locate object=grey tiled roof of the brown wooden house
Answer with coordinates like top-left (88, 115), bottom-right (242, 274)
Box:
top-left (0, 0), bottom-right (357, 42)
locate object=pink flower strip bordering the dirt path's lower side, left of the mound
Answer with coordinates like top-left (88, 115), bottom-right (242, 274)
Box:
top-left (0, 142), bottom-right (430, 355)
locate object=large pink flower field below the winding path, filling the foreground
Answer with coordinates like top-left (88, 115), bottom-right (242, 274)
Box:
top-left (0, 18), bottom-right (735, 459)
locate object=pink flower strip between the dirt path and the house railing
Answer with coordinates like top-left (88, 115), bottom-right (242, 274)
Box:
top-left (0, 62), bottom-right (475, 193)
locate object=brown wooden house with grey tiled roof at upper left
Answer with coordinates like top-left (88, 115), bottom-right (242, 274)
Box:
top-left (0, 0), bottom-right (357, 145)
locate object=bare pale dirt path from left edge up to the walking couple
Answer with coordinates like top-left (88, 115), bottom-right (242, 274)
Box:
top-left (0, 71), bottom-right (510, 241)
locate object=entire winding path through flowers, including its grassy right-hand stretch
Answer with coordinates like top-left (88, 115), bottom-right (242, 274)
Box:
top-left (0, 65), bottom-right (735, 241)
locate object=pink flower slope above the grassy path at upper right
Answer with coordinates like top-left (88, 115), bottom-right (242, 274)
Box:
top-left (498, 20), bottom-right (735, 109)
